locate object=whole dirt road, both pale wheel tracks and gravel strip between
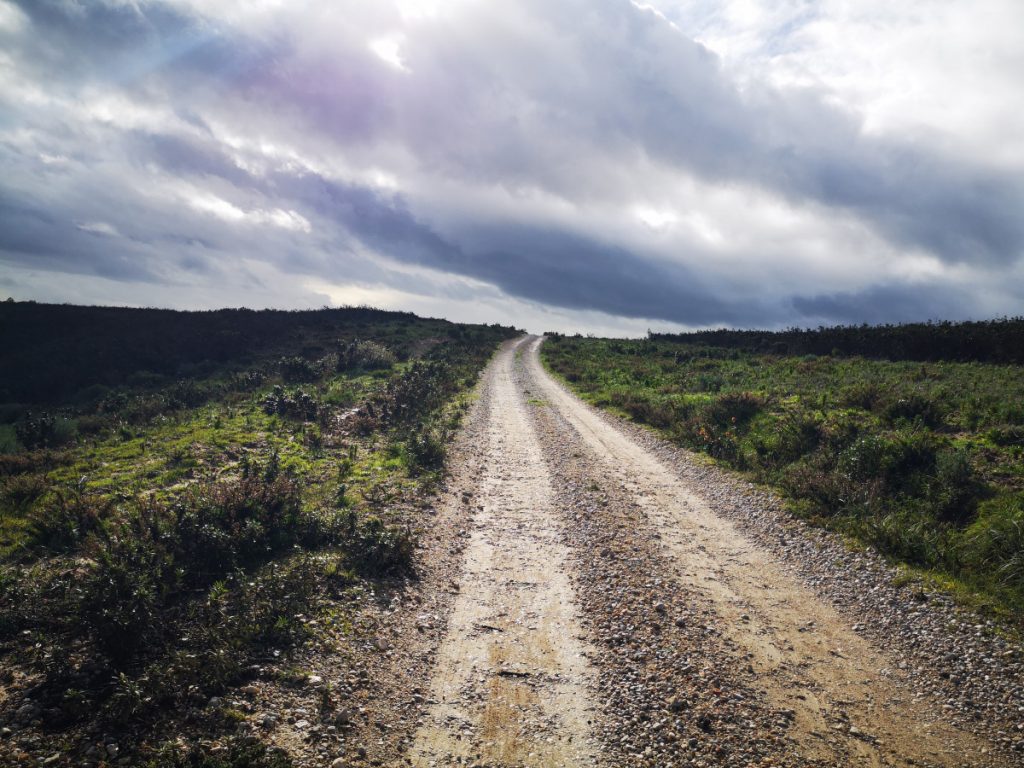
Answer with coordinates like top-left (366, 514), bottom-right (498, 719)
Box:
top-left (407, 338), bottom-right (1015, 766)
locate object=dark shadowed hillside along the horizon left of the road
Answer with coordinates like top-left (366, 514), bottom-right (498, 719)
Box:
top-left (0, 301), bottom-right (512, 403)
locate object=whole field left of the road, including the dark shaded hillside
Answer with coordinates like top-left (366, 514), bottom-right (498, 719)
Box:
top-left (0, 303), bottom-right (516, 766)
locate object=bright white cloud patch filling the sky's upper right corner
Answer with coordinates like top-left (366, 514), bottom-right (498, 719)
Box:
top-left (652, 0), bottom-right (1024, 168)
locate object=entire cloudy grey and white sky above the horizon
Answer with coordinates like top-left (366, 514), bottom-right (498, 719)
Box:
top-left (0, 0), bottom-right (1024, 334)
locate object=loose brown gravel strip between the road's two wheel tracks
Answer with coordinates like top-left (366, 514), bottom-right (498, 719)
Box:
top-left (520, 358), bottom-right (812, 767)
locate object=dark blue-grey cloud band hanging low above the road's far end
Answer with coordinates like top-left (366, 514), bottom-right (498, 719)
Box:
top-left (247, 167), bottom-right (766, 324)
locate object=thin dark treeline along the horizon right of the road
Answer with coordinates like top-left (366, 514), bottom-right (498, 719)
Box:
top-left (648, 317), bottom-right (1024, 364)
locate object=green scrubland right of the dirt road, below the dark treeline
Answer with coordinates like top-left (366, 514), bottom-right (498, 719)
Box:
top-left (542, 322), bottom-right (1024, 623)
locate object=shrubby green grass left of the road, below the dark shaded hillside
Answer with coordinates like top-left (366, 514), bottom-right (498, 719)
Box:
top-left (0, 315), bottom-right (514, 764)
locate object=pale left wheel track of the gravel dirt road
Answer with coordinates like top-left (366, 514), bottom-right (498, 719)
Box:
top-left (409, 344), bottom-right (597, 768)
